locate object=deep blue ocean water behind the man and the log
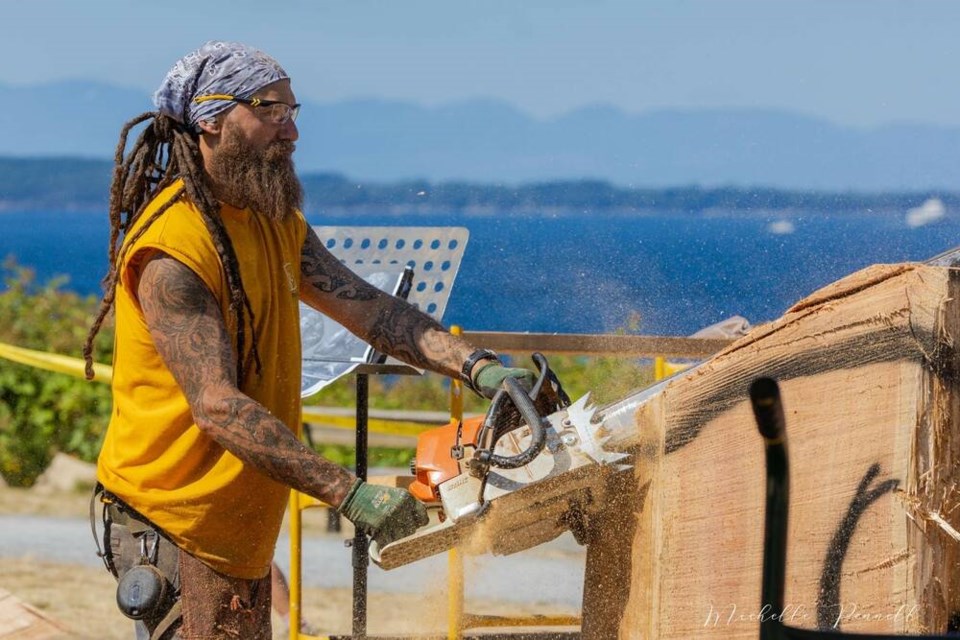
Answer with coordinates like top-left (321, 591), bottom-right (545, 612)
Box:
top-left (0, 211), bottom-right (960, 335)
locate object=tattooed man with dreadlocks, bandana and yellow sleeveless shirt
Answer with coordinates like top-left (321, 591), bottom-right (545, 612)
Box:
top-left (84, 42), bottom-right (533, 640)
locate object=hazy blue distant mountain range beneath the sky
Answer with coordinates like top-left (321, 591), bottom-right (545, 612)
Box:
top-left (0, 81), bottom-right (960, 191)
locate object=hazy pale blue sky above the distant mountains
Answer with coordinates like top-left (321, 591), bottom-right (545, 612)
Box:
top-left (0, 0), bottom-right (960, 126)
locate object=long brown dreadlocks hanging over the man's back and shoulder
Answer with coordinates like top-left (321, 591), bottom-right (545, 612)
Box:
top-left (83, 111), bottom-right (261, 384)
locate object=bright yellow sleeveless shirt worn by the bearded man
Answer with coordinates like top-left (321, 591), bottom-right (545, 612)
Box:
top-left (97, 181), bottom-right (306, 579)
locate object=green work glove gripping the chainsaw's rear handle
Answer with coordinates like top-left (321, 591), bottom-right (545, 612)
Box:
top-left (337, 480), bottom-right (429, 548)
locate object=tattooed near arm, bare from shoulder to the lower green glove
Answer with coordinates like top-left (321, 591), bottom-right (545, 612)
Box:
top-left (137, 253), bottom-right (355, 506)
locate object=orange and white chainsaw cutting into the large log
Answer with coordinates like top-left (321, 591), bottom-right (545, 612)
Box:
top-left (370, 353), bottom-right (645, 569)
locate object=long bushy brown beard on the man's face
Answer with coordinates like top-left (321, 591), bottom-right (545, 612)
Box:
top-left (206, 123), bottom-right (303, 221)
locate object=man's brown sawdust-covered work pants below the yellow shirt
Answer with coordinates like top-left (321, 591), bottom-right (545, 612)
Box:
top-left (110, 506), bottom-right (272, 640)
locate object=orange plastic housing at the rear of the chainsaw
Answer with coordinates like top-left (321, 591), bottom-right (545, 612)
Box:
top-left (409, 416), bottom-right (483, 503)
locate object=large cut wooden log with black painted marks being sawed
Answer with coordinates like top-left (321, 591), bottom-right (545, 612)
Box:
top-left (583, 265), bottom-right (960, 638)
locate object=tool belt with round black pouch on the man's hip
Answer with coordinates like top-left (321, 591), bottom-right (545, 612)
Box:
top-left (90, 483), bottom-right (181, 640)
